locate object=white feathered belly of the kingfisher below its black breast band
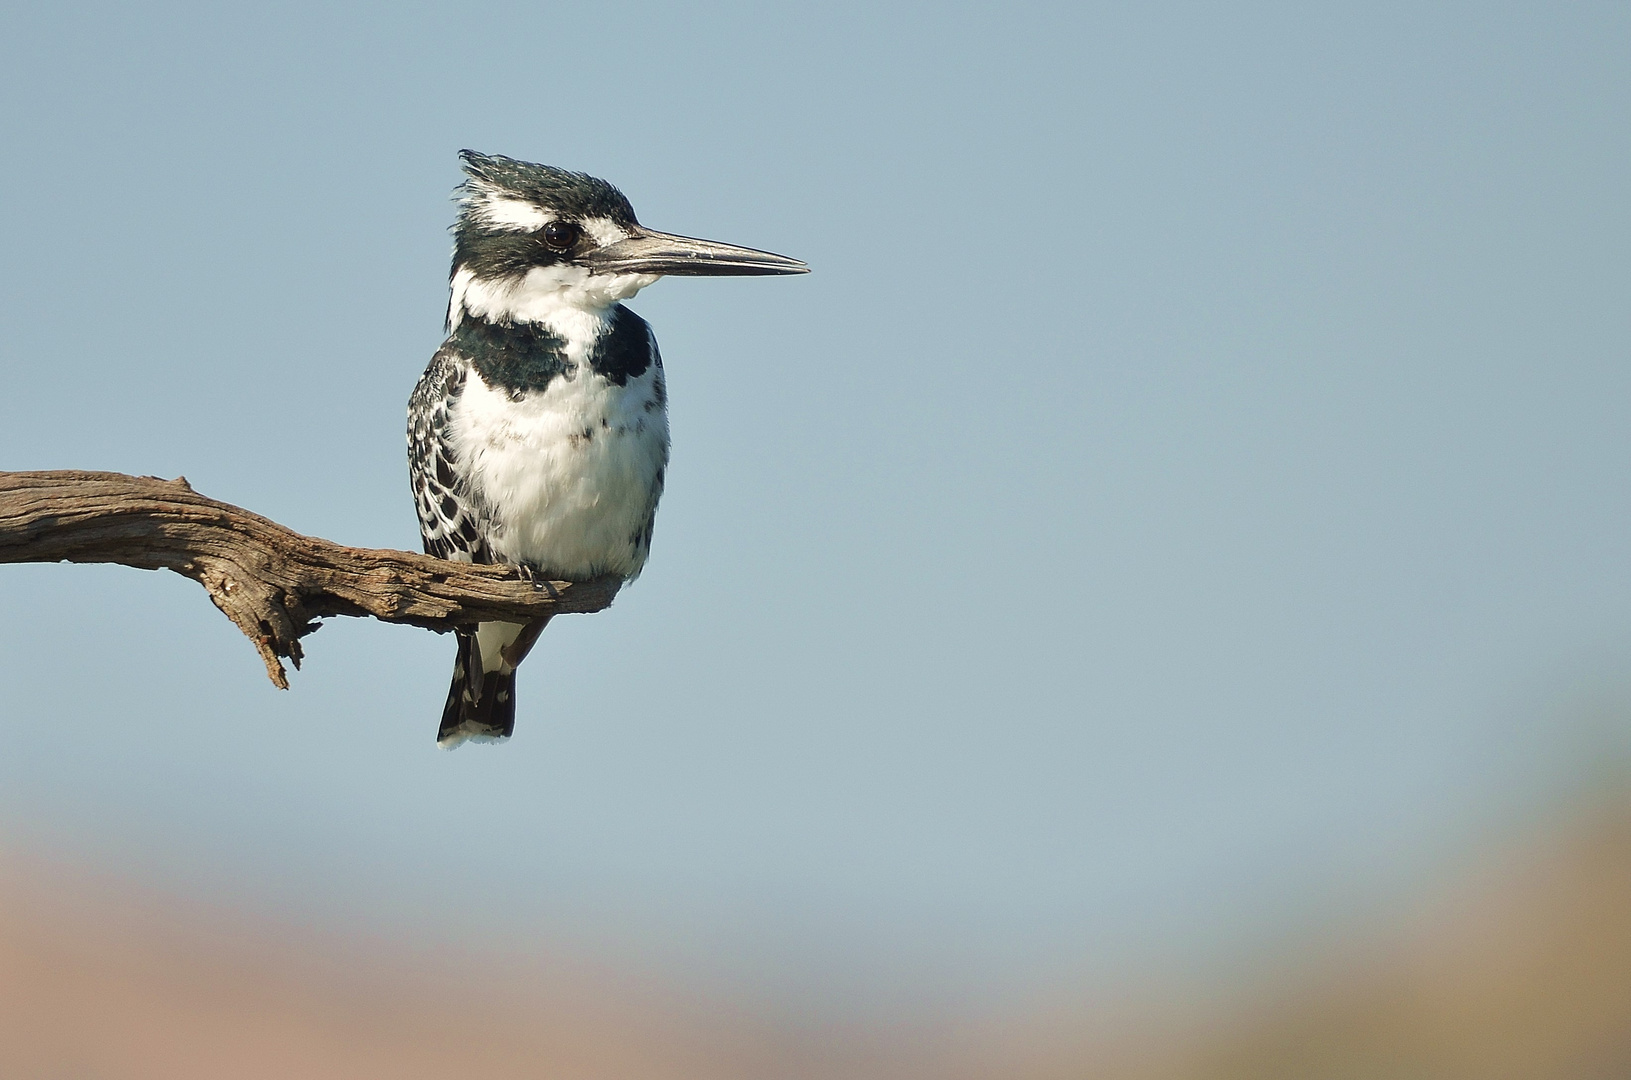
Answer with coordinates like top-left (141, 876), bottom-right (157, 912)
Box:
top-left (449, 365), bottom-right (669, 579)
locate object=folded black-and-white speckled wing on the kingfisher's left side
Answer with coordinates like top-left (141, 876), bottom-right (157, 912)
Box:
top-left (408, 343), bottom-right (494, 563)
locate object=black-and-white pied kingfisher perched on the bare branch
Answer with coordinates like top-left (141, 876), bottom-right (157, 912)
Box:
top-left (408, 150), bottom-right (809, 749)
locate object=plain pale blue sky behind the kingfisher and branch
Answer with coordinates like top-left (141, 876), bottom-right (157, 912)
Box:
top-left (0, 3), bottom-right (1631, 1018)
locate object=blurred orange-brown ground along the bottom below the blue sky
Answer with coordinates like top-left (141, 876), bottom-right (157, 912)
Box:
top-left (0, 801), bottom-right (1631, 1080)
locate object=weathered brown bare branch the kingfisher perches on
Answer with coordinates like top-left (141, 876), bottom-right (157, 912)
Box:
top-left (0, 471), bottom-right (621, 690)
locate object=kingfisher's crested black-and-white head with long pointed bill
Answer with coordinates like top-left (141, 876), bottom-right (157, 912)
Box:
top-left (449, 150), bottom-right (809, 326)
